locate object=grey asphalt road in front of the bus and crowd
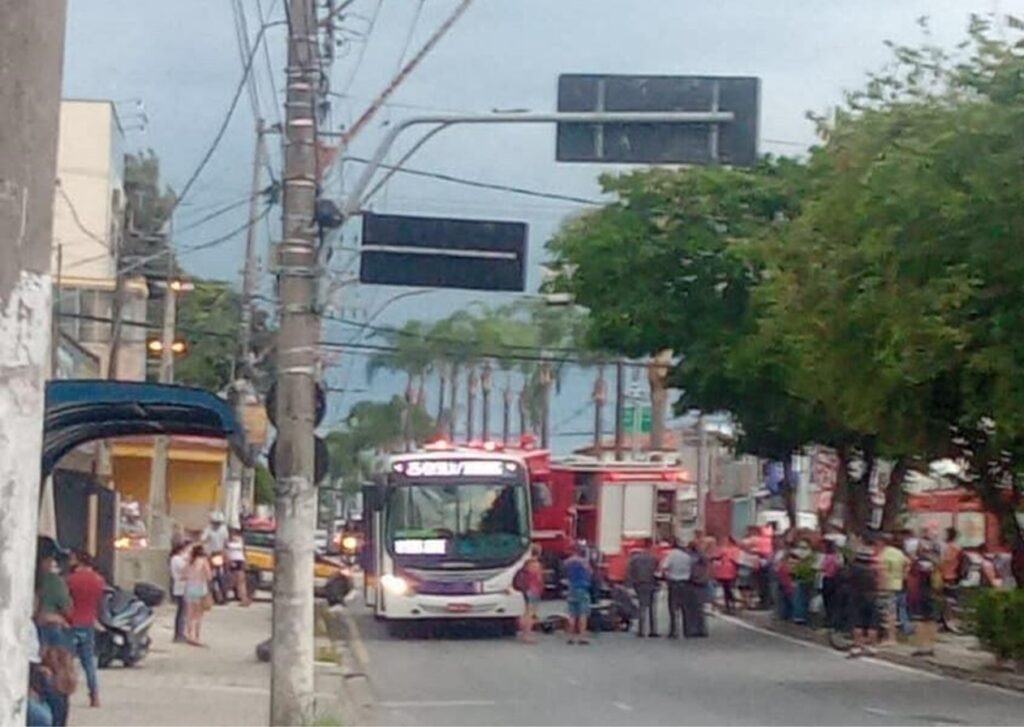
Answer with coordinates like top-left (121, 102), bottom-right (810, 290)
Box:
top-left (348, 604), bottom-right (1024, 725)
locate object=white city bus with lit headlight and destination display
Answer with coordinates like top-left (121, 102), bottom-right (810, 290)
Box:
top-left (364, 448), bottom-right (530, 633)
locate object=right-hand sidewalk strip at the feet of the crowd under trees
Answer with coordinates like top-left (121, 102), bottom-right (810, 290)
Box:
top-left (738, 611), bottom-right (1024, 691)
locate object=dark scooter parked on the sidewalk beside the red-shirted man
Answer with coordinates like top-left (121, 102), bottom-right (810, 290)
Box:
top-left (96, 585), bottom-right (156, 669)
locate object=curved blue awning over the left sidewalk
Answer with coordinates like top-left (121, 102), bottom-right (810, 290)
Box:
top-left (42, 379), bottom-right (245, 477)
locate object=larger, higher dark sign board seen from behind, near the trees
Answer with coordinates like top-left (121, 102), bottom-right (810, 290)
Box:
top-left (555, 74), bottom-right (761, 167)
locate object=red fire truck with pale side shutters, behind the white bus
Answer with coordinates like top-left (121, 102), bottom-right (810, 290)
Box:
top-left (534, 458), bottom-right (696, 583)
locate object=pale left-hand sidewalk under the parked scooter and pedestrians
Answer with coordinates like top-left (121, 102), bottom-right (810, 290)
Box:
top-left (70, 602), bottom-right (346, 727)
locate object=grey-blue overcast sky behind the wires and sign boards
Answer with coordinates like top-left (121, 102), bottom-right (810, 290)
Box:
top-left (65, 0), bottom-right (1024, 450)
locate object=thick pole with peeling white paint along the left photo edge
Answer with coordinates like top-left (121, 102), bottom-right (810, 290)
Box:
top-left (0, 0), bottom-right (65, 727)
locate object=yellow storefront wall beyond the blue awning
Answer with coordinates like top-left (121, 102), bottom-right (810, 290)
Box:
top-left (113, 436), bottom-right (227, 530)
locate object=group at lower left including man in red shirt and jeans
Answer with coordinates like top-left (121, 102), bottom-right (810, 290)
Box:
top-left (28, 548), bottom-right (106, 726)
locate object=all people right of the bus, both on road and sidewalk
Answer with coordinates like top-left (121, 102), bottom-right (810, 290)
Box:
top-left (516, 525), bottom-right (1013, 656)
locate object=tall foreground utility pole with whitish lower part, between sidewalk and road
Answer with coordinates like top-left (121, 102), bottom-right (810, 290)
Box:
top-left (270, 0), bottom-right (319, 725)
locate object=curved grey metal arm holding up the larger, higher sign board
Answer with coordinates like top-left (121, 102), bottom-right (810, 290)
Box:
top-left (342, 112), bottom-right (735, 217)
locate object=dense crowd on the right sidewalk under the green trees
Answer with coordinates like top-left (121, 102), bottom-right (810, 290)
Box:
top-left (711, 528), bottom-right (1013, 656)
